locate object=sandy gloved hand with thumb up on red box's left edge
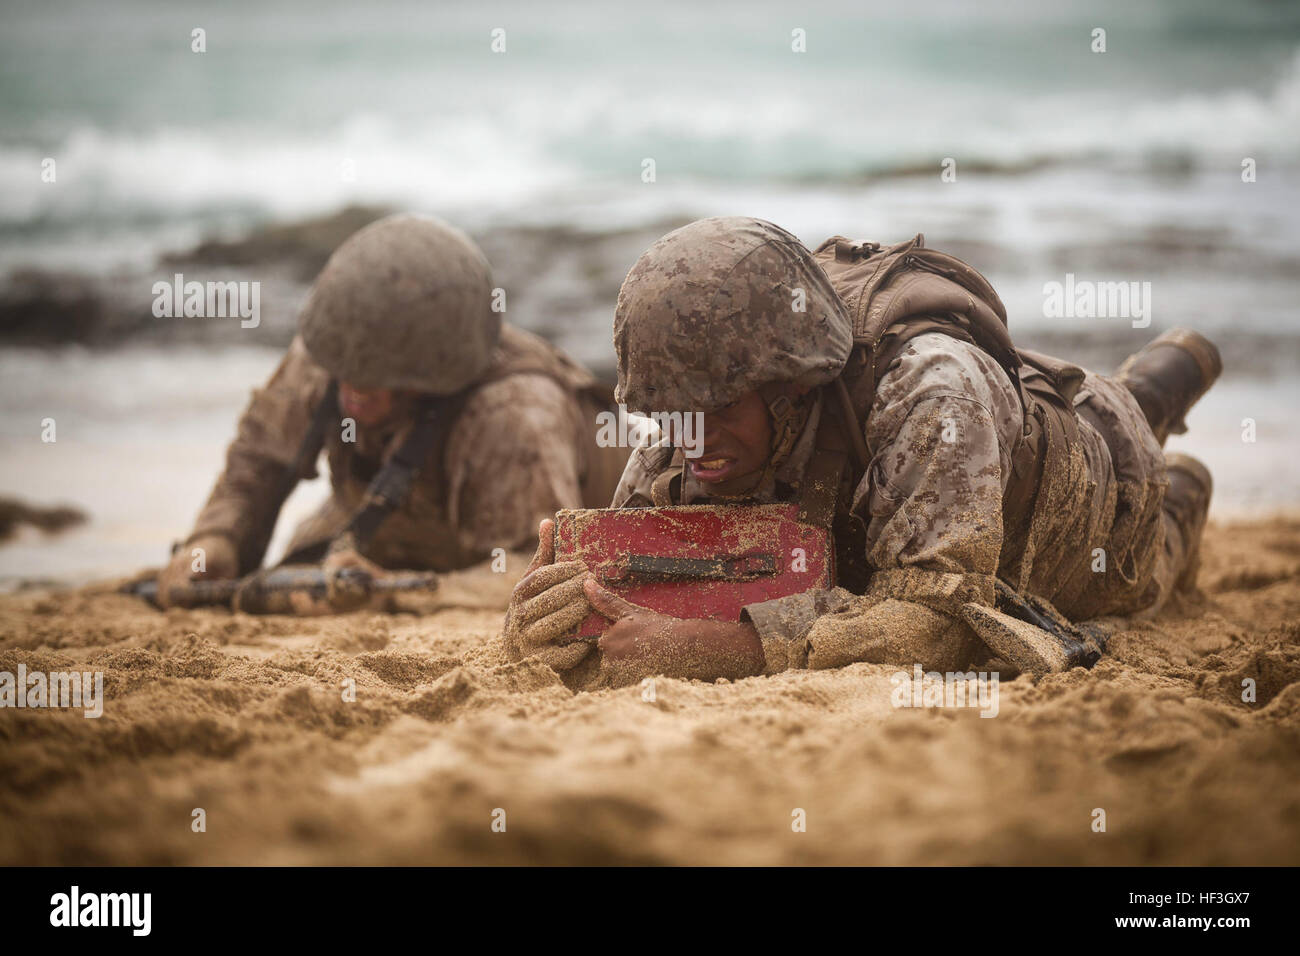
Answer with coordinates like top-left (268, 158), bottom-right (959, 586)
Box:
top-left (504, 518), bottom-right (594, 671)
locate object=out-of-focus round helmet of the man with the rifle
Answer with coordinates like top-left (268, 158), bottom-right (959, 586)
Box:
top-left (298, 215), bottom-right (501, 395)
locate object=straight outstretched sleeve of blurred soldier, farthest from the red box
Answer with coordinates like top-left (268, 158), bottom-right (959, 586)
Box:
top-left (189, 338), bottom-right (329, 572)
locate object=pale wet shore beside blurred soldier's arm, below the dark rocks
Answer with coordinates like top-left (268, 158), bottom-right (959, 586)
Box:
top-left (0, 346), bottom-right (328, 588)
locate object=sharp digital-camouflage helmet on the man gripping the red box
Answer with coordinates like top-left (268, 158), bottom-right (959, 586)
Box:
top-left (614, 217), bottom-right (853, 411)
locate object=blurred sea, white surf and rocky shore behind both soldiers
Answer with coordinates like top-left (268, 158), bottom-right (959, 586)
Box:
top-left (0, 0), bottom-right (1300, 587)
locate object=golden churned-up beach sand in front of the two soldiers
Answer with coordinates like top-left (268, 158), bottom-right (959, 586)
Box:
top-left (0, 518), bottom-right (1300, 865)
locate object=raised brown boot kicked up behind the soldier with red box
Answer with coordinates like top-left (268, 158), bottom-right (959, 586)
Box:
top-left (1114, 329), bottom-right (1223, 445)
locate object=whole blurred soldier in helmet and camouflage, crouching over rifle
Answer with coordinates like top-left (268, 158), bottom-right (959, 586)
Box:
top-left (182, 213), bottom-right (625, 575)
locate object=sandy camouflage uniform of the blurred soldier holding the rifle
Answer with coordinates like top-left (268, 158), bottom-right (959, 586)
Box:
top-left (191, 325), bottom-right (625, 572)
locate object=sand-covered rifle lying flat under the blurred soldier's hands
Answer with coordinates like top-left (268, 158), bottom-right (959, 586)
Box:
top-left (120, 567), bottom-right (438, 614)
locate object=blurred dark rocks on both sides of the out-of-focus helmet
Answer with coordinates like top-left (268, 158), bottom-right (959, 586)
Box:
top-left (0, 206), bottom-right (689, 380)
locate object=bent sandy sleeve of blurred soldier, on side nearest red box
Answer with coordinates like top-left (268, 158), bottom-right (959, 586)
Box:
top-left (446, 375), bottom-right (594, 554)
